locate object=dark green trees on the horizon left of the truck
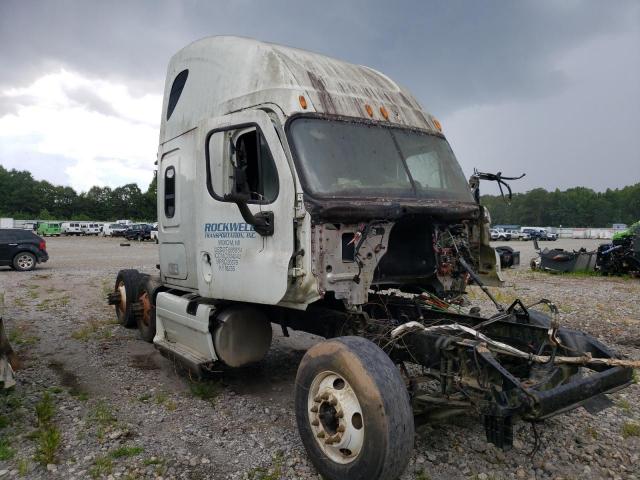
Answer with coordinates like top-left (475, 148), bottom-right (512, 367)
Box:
top-left (0, 165), bottom-right (156, 221)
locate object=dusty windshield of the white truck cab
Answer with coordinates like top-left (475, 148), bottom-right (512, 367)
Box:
top-left (289, 117), bottom-right (473, 202)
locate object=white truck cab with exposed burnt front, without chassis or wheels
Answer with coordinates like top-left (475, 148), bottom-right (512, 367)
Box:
top-left (158, 37), bottom-right (496, 316)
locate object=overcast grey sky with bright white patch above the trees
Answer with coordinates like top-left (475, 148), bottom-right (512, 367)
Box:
top-left (0, 0), bottom-right (640, 193)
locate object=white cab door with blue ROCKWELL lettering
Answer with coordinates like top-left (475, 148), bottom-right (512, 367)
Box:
top-left (198, 110), bottom-right (295, 304)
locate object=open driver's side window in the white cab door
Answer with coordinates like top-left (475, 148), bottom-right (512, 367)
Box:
top-left (207, 127), bottom-right (279, 203)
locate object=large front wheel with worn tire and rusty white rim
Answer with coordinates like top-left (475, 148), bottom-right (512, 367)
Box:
top-left (295, 337), bottom-right (414, 480)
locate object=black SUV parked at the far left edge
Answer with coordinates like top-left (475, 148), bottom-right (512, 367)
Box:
top-left (0, 228), bottom-right (49, 272)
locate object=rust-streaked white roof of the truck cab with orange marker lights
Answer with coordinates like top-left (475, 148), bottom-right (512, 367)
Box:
top-left (160, 36), bottom-right (440, 144)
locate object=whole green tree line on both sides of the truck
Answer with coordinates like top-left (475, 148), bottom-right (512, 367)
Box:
top-left (0, 165), bottom-right (640, 227)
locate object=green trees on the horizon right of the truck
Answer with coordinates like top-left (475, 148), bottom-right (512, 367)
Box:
top-left (481, 183), bottom-right (640, 227)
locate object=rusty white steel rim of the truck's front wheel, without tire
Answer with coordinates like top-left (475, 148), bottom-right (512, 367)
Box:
top-left (307, 371), bottom-right (365, 465)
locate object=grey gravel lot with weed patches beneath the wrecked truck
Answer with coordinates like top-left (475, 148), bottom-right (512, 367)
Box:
top-left (0, 237), bottom-right (640, 480)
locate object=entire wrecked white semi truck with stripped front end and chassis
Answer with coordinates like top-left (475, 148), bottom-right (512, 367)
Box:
top-left (109, 37), bottom-right (632, 480)
